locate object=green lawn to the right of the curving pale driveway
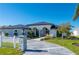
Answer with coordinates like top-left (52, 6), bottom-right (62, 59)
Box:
top-left (46, 38), bottom-right (79, 55)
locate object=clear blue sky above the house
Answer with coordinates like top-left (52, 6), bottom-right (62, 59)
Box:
top-left (0, 3), bottom-right (79, 27)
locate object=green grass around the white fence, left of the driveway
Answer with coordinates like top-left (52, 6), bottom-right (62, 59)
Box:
top-left (0, 42), bottom-right (22, 55)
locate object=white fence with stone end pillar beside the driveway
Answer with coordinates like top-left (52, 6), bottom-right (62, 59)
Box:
top-left (0, 36), bottom-right (27, 51)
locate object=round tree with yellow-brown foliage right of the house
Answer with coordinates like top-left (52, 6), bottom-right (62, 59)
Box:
top-left (57, 23), bottom-right (71, 38)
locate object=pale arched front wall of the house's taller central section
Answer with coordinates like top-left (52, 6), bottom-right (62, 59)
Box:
top-left (29, 25), bottom-right (57, 37)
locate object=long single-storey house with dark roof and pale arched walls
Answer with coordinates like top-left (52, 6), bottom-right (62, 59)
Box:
top-left (0, 22), bottom-right (57, 37)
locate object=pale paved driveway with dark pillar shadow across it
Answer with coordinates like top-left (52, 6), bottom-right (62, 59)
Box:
top-left (24, 40), bottom-right (74, 55)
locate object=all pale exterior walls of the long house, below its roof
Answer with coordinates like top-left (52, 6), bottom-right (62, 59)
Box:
top-left (0, 25), bottom-right (57, 37)
